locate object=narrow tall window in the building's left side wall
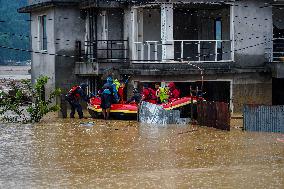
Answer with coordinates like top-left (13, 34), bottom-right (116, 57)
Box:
top-left (38, 15), bottom-right (47, 51)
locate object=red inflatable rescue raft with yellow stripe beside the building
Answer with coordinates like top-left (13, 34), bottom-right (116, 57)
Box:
top-left (88, 96), bottom-right (205, 118)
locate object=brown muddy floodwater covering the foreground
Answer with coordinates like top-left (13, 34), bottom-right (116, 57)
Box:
top-left (0, 119), bottom-right (284, 188)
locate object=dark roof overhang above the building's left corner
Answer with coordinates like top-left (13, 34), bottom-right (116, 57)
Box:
top-left (18, 0), bottom-right (79, 13)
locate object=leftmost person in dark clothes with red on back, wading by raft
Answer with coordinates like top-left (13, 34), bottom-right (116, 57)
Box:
top-left (65, 83), bottom-right (89, 119)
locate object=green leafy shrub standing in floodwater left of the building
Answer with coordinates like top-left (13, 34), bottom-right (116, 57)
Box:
top-left (0, 76), bottom-right (61, 123)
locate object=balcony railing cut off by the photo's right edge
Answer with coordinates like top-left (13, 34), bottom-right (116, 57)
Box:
top-left (270, 38), bottom-right (284, 62)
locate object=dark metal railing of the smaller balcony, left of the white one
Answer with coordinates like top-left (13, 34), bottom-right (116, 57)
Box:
top-left (76, 40), bottom-right (129, 63)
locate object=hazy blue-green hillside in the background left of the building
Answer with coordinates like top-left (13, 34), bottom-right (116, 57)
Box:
top-left (0, 0), bottom-right (30, 64)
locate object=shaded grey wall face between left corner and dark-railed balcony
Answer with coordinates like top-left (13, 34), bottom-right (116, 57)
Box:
top-left (54, 7), bottom-right (85, 89)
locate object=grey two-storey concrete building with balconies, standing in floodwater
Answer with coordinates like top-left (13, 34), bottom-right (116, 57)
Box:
top-left (19, 0), bottom-right (284, 112)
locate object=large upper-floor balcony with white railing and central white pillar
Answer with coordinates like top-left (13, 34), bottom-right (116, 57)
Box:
top-left (130, 4), bottom-right (234, 64)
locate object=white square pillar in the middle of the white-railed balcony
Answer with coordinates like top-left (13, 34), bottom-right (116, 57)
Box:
top-left (161, 4), bottom-right (174, 61)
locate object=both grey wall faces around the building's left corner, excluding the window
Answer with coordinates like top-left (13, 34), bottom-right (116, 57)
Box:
top-left (31, 7), bottom-right (85, 97)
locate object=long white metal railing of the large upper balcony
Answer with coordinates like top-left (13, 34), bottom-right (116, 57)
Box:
top-left (132, 40), bottom-right (233, 63)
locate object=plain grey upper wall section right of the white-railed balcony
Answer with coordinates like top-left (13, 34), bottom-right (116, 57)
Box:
top-left (233, 0), bottom-right (272, 68)
